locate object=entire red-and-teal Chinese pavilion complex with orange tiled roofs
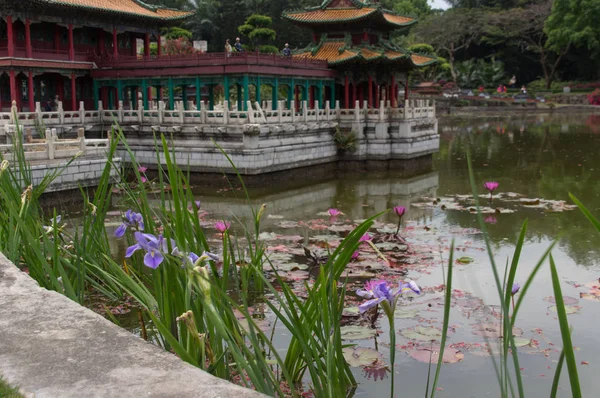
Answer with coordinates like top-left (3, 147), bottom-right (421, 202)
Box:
top-left (0, 0), bottom-right (435, 112)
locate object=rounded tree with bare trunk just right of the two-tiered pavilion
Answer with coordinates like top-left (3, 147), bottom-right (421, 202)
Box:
top-left (415, 9), bottom-right (484, 83)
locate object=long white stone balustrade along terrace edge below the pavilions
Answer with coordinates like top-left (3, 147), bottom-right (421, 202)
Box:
top-left (0, 100), bottom-right (435, 128)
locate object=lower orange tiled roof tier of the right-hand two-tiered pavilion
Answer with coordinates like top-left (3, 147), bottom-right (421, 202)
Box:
top-left (293, 39), bottom-right (437, 67)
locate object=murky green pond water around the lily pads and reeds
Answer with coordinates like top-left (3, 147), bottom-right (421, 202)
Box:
top-left (88, 113), bottom-right (600, 397)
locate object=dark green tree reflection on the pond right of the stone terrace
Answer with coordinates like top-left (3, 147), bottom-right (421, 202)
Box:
top-left (436, 115), bottom-right (600, 265)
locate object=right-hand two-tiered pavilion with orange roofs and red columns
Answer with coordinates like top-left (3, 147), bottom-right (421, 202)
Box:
top-left (283, 0), bottom-right (436, 108)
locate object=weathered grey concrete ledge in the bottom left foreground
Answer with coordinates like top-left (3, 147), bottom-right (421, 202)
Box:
top-left (0, 254), bottom-right (264, 398)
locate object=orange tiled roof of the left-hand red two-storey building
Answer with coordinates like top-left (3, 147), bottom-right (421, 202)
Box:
top-left (33, 0), bottom-right (194, 21)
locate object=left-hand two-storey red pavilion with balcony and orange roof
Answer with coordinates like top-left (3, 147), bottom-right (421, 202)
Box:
top-left (0, 0), bottom-right (192, 111)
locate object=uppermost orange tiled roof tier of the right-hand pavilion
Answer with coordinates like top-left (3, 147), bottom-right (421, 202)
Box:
top-left (283, 0), bottom-right (417, 29)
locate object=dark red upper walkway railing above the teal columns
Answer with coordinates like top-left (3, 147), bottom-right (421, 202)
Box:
top-left (91, 52), bottom-right (327, 69)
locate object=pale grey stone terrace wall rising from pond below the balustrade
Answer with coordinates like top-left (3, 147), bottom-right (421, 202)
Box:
top-left (109, 118), bottom-right (439, 175)
